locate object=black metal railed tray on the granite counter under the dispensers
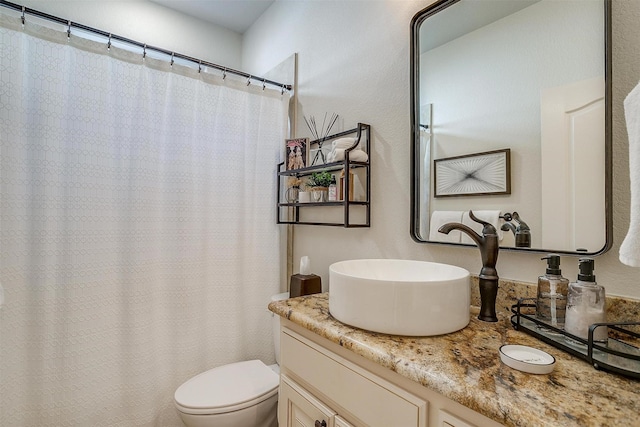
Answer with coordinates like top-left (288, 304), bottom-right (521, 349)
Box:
top-left (511, 298), bottom-right (640, 378)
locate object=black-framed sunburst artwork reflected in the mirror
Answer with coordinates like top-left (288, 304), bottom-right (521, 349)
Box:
top-left (433, 148), bottom-right (511, 197)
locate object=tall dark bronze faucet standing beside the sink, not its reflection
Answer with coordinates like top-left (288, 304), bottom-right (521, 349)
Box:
top-left (438, 211), bottom-right (498, 322)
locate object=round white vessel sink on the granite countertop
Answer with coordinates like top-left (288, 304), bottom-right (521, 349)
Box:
top-left (329, 259), bottom-right (470, 336)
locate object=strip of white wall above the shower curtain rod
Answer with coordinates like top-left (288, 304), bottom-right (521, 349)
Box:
top-left (18, 0), bottom-right (242, 69)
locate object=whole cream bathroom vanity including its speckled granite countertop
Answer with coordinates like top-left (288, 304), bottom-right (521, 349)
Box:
top-left (269, 292), bottom-right (640, 427)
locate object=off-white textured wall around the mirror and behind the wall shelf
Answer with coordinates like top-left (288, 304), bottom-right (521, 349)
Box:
top-left (242, 0), bottom-right (640, 298)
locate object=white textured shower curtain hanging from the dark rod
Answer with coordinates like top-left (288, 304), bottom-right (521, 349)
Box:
top-left (0, 16), bottom-right (288, 427)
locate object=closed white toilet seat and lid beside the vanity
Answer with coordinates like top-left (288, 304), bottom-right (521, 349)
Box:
top-left (174, 360), bottom-right (280, 415)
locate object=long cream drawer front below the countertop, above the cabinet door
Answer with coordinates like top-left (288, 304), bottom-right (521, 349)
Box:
top-left (280, 328), bottom-right (427, 427)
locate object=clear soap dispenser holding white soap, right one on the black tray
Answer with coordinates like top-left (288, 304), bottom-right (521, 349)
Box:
top-left (564, 258), bottom-right (608, 342)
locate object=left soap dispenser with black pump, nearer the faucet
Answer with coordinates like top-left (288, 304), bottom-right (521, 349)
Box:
top-left (536, 254), bottom-right (569, 329)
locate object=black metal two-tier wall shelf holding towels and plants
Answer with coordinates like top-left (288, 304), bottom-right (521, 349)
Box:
top-left (276, 123), bottom-right (371, 228)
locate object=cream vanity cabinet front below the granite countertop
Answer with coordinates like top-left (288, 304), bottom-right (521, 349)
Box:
top-left (278, 319), bottom-right (500, 427)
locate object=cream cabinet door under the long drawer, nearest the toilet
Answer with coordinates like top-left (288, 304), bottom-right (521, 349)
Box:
top-left (278, 375), bottom-right (338, 427)
